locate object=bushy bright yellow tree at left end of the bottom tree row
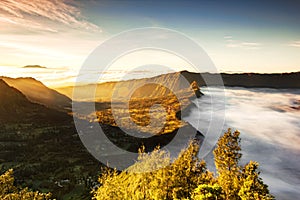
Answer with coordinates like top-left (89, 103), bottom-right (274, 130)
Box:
top-left (93, 149), bottom-right (170, 200)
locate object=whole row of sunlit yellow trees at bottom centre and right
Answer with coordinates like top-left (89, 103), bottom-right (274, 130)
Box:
top-left (93, 129), bottom-right (274, 200)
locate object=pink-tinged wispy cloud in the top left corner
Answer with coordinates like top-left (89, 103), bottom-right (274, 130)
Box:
top-left (0, 0), bottom-right (101, 32)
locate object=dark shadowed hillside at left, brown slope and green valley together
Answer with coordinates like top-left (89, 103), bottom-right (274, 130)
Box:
top-left (0, 79), bottom-right (100, 199)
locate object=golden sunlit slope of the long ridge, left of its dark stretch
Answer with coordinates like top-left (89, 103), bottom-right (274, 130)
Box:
top-left (56, 72), bottom-right (200, 101)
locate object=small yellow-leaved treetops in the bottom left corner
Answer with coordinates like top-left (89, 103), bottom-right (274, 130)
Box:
top-left (0, 169), bottom-right (51, 200)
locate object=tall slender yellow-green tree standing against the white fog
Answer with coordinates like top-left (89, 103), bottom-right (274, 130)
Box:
top-left (214, 129), bottom-right (242, 200)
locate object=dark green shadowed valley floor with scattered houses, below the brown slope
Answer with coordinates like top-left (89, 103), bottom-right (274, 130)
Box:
top-left (0, 123), bottom-right (101, 200)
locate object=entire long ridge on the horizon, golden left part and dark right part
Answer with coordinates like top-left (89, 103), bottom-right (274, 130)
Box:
top-left (56, 71), bottom-right (300, 101)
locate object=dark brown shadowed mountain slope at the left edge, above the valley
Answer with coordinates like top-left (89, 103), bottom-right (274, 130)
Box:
top-left (0, 79), bottom-right (71, 124)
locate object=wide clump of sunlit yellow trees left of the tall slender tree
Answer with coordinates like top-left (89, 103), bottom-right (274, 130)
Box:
top-left (94, 143), bottom-right (213, 200)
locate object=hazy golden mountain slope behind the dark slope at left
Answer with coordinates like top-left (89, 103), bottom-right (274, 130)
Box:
top-left (0, 77), bottom-right (71, 111)
